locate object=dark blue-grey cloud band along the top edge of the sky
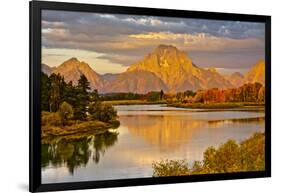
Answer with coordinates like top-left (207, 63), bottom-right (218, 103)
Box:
top-left (42, 11), bottom-right (264, 38)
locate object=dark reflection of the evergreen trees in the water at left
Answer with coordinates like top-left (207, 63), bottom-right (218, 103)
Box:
top-left (41, 131), bottom-right (118, 174)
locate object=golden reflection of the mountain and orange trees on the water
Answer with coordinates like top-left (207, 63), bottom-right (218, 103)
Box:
top-left (120, 115), bottom-right (264, 151)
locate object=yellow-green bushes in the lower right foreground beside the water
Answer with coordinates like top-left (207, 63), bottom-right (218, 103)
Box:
top-left (152, 133), bottom-right (265, 177)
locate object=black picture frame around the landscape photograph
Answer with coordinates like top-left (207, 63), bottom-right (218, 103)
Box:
top-left (29, 1), bottom-right (271, 192)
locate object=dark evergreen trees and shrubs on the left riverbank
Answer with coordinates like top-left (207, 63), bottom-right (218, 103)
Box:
top-left (41, 73), bottom-right (119, 137)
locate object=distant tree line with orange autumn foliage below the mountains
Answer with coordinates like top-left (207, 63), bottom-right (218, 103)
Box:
top-left (100, 82), bottom-right (265, 103)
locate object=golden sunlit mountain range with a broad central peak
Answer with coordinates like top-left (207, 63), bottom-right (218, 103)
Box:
top-left (42, 45), bottom-right (265, 93)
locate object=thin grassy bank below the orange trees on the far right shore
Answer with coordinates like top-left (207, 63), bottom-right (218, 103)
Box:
top-left (168, 102), bottom-right (264, 110)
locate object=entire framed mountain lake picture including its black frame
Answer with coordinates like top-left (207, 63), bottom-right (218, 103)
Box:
top-left (29, 1), bottom-right (271, 192)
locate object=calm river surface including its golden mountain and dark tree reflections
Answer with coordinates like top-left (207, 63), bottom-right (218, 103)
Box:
top-left (42, 105), bottom-right (265, 183)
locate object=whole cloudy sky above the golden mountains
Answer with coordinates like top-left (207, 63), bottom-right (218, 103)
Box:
top-left (42, 10), bottom-right (265, 74)
